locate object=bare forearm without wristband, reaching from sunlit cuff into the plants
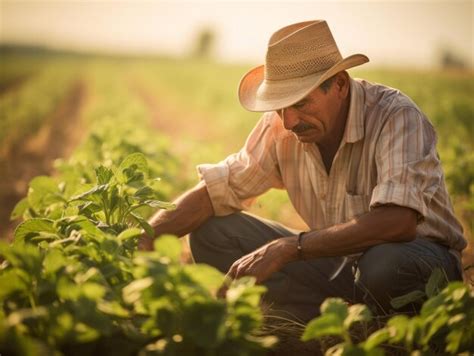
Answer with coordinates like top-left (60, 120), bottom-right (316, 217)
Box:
top-left (149, 182), bottom-right (214, 236)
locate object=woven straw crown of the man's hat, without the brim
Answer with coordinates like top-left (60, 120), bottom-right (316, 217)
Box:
top-left (264, 20), bottom-right (342, 80)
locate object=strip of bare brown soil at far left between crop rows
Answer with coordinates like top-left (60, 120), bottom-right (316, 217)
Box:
top-left (0, 82), bottom-right (87, 240)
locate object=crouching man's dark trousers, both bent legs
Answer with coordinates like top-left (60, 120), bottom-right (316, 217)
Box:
top-left (189, 213), bottom-right (461, 322)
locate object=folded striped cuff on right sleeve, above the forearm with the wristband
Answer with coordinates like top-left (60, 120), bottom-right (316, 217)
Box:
top-left (370, 182), bottom-right (432, 224)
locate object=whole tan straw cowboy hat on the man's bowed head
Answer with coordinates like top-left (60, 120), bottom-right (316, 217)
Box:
top-left (239, 20), bottom-right (369, 111)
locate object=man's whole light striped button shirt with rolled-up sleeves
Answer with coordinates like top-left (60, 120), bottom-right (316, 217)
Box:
top-left (197, 79), bottom-right (466, 254)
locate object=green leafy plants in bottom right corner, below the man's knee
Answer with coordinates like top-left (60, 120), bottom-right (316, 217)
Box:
top-left (302, 269), bottom-right (474, 356)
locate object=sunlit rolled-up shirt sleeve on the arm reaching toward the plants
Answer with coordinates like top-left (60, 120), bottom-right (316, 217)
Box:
top-left (197, 113), bottom-right (283, 216)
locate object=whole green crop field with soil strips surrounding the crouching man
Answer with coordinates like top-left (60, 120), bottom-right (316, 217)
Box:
top-left (0, 53), bottom-right (474, 355)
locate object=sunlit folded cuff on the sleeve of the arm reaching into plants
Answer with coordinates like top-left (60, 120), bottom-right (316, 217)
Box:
top-left (196, 162), bottom-right (254, 216)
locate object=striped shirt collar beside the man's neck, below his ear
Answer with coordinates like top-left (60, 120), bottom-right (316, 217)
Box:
top-left (344, 78), bottom-right (365, 143)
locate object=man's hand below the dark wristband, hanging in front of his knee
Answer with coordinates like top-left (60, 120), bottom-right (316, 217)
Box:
top-left (217, 237), bottom-right (297, 297)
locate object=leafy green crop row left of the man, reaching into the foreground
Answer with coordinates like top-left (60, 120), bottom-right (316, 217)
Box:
top-left (0, 63), bottom-right (272, 355)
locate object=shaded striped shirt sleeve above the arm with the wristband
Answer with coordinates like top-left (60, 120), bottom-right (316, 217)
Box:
top-left (370, 107), bottom-right (443, 223)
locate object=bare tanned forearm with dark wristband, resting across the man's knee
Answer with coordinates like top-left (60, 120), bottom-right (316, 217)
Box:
top-left (286, 206), bottom-right (416, 261)
